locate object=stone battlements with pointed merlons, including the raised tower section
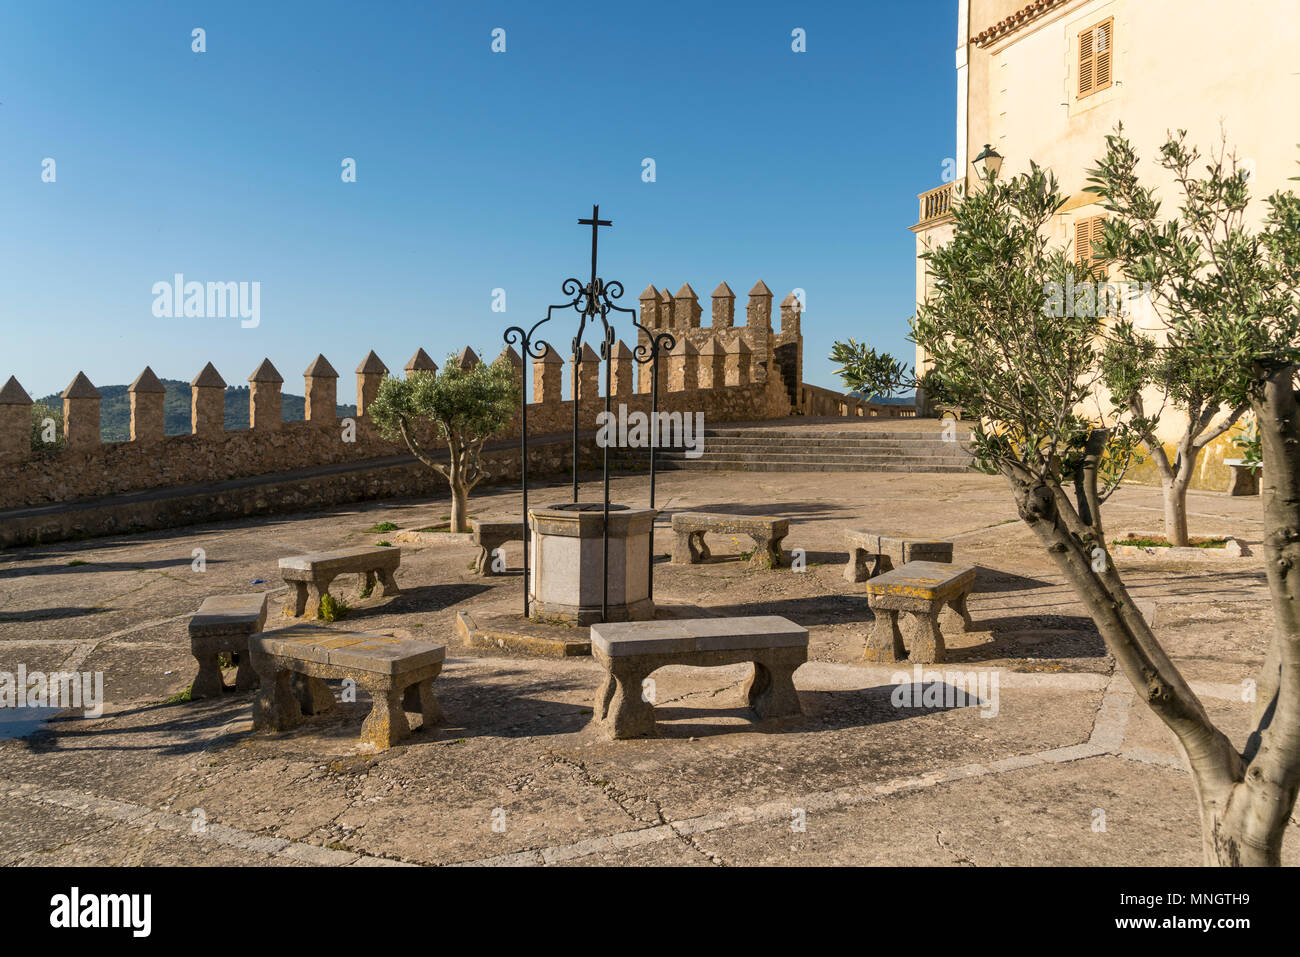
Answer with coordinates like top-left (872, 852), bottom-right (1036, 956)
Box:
top-left (0, 282), bottom-right (832, 520)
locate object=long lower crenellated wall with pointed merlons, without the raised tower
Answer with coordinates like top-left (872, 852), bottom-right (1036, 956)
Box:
top-left (0, 299), bottom-right (790, 510)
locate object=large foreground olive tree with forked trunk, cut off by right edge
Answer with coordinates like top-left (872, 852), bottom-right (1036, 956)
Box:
top-left (913, 142), bottom-right (1300, 865)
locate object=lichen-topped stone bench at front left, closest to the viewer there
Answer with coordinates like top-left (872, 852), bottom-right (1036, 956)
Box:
top-left (248, 624), bottom-right (446, 750)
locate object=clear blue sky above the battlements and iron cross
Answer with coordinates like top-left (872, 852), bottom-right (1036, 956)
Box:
top-left (0, 0), bottom-right (956, 400)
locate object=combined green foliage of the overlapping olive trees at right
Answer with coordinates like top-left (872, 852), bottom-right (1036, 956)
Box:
top-left (913, 126), bottom-right (1300, 538)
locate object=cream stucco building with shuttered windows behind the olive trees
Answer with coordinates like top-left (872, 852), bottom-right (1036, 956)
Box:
top-left (911, 0), bottom-right (1300, 488)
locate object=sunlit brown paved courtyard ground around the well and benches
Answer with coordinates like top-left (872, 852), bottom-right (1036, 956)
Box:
top-left (0, 472), bottom-right (1300, 865)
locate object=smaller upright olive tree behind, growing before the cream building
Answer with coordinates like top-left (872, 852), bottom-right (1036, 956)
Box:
top-left (1092, 125), bottom-right (1257, 545)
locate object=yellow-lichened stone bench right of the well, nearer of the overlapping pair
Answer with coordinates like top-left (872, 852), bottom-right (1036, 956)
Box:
top-left (863, 562), bottom-right (975, 664)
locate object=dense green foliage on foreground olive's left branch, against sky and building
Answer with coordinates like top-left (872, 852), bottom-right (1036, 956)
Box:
top-left (913, 164), bottom-right (1101, 486)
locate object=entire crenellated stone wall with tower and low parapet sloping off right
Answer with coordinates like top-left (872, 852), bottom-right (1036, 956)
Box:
top-left (0, 281), bottom-right (899, 544)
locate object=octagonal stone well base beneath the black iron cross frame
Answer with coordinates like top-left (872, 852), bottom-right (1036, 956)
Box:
top-left (528, 502), bottom-right (658, 624)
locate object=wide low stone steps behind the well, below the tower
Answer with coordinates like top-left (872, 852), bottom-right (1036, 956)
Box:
top-left (610, 426), bottom-right (972, 472)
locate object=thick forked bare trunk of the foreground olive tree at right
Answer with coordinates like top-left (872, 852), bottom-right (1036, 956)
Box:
top-left (1008, 368), bottom-right (1300, 867)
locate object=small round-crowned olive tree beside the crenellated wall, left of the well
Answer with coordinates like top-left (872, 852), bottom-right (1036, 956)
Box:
top-left (365, 356), bottom-right (520, 532)
